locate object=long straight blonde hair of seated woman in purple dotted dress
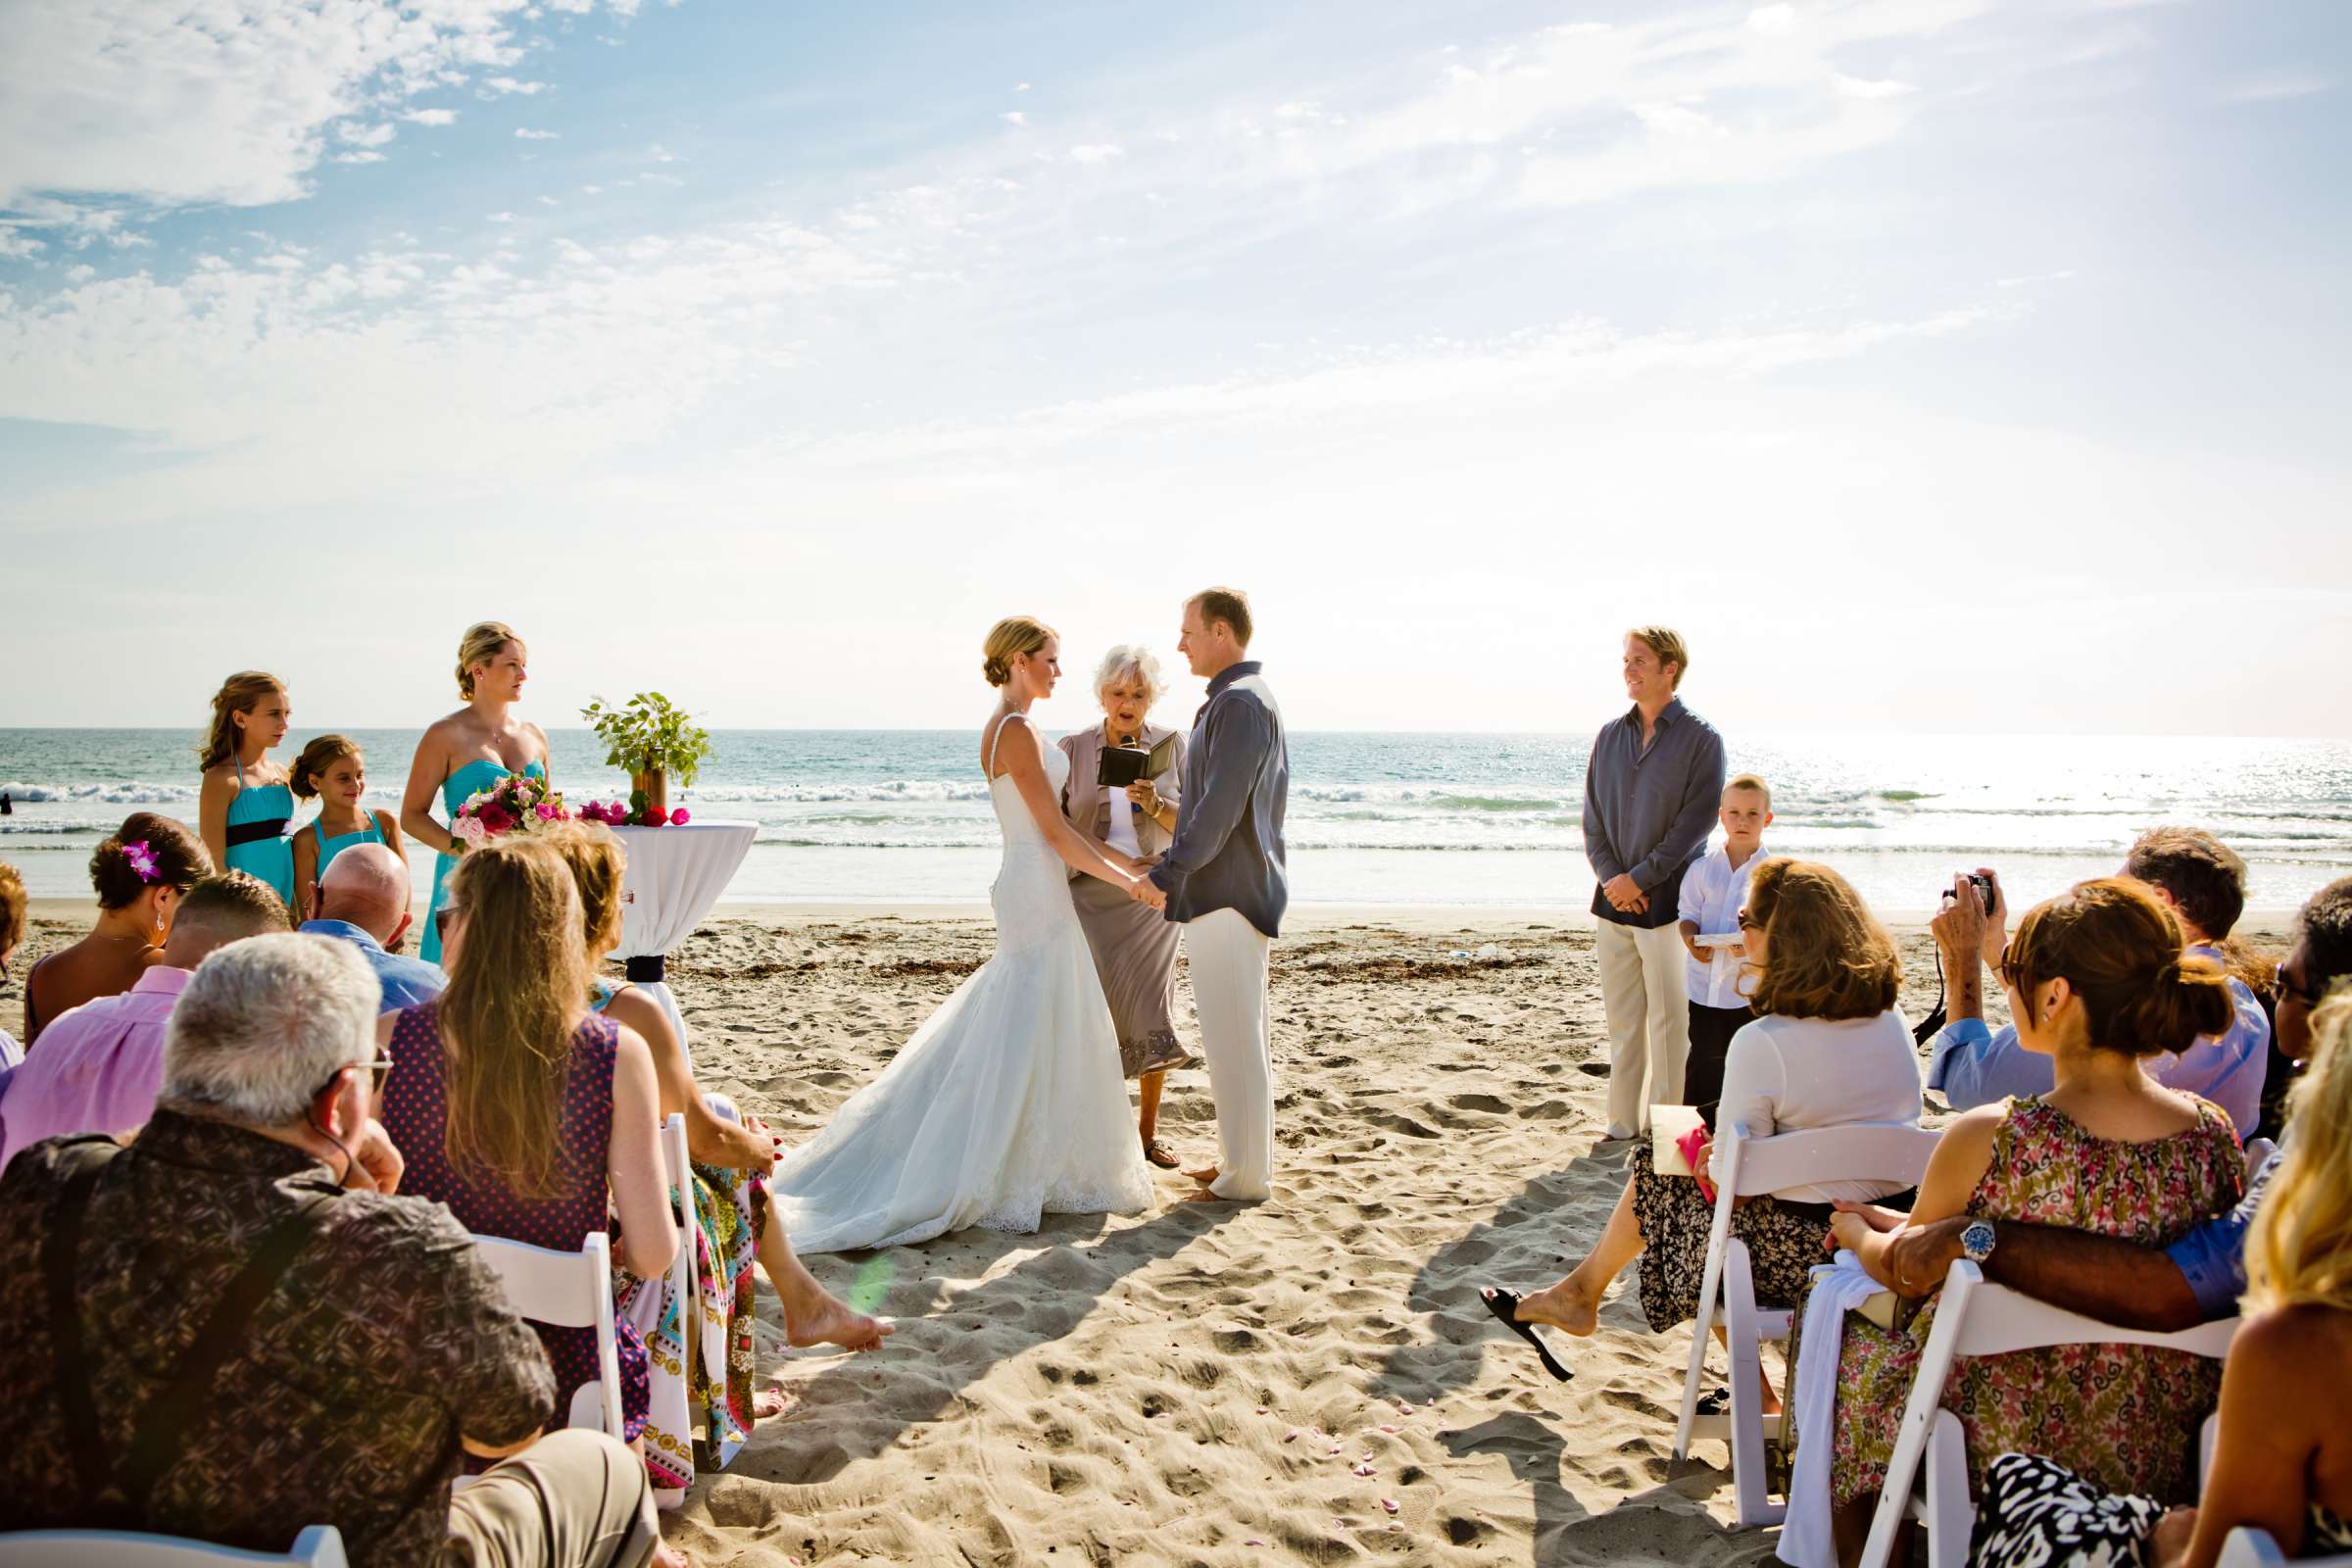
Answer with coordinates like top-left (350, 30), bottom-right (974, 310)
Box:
top-left (440, 837), bottom-right (588, 1199)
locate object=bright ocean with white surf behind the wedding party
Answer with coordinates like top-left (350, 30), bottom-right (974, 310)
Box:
top-left (0, 729), bottom-right (2352, 914)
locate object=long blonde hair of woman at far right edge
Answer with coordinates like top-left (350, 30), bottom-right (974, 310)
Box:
top-left (2246, 987), bottom-right (2352, 1312)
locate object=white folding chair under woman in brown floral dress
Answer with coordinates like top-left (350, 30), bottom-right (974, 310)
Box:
top-left (1863, 1257), bottom-right (2236, 1568)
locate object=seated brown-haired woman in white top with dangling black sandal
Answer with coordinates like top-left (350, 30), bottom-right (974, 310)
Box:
top-left (1484, 860), bottom-right (1919, 1410)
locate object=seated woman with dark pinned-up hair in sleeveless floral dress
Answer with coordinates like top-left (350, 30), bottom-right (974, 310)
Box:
top-left (1830, 879), bottom-right (2246, 1554)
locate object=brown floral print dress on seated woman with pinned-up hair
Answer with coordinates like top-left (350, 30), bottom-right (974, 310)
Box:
top-left (1830, 1096), bottom-right (2246, 1504)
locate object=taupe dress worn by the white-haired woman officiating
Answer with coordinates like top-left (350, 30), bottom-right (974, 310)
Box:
top-left (1060, 724), bottom-right (1193, 1077)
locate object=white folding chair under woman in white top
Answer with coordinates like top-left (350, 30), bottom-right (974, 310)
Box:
top-left (1675, 1124), bottom-right (1938, 1528)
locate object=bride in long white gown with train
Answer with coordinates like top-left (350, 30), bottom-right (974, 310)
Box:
top-left (769, 615), bottom-right (1164, 1253)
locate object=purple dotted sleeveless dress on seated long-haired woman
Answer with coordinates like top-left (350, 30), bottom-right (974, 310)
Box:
top-left (376, 1002), bottom-right (652, 1441)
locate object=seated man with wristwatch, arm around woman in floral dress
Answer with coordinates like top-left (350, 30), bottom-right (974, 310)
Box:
top-left (1833, 877), bottom-right (2352, 1333)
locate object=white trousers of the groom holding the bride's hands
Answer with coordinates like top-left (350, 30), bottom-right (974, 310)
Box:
top-left (1183, 909), bottom-right (1275, 1199)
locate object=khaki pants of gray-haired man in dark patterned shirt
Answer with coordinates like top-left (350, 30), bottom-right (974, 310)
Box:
top-left (442, 1427), bottom-right (661, 1568)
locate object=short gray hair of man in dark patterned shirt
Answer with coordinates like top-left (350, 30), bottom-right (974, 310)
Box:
top-left (158, 931), bottom-right (383, 1126)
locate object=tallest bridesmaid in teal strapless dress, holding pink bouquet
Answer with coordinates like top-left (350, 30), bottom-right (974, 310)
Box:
top-left (400, 620), bottom-right (548, 964)
